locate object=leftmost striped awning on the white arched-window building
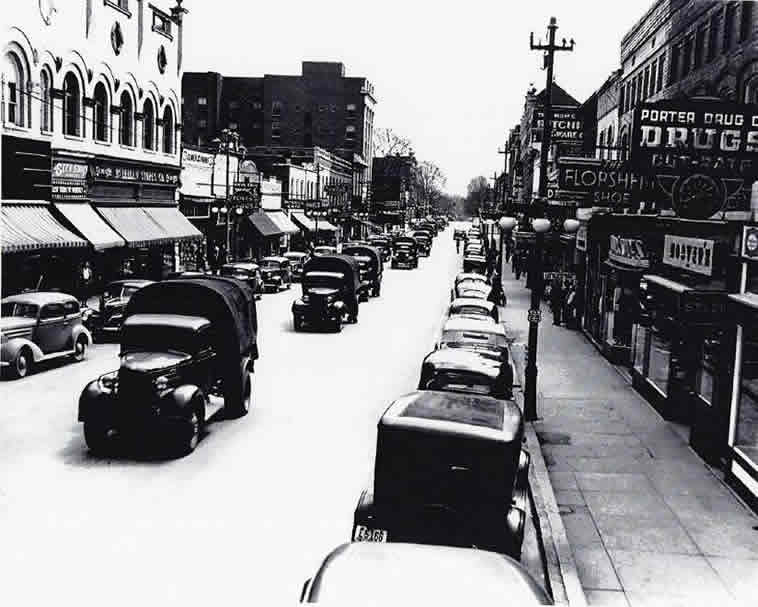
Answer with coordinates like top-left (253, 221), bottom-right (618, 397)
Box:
top-left (0, 201), bottom-right (88, 253)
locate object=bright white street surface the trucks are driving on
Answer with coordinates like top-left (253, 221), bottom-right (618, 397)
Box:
top-left (0, 228), bottom-right (464, 605)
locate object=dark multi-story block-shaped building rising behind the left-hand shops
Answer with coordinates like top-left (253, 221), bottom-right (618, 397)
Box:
top-left (183, 61), bottom-right (376, 205)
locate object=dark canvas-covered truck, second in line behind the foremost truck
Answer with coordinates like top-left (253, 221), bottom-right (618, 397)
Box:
top-left (292, 255), bottom-right (361, 332)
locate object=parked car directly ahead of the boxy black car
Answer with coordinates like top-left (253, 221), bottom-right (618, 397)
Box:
top-left (418, 348), bottom-right (513, 400)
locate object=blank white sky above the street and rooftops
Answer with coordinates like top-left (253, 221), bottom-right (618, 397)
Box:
top-left (184, 0), bottom-right (653, 194)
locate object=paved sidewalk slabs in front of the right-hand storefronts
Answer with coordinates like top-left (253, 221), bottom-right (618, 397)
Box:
top-left (503, 268), bottom-right (758, 607)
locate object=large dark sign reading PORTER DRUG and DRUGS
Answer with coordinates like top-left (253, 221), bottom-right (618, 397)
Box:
top-left (630, 99), bottom-right (758, 219)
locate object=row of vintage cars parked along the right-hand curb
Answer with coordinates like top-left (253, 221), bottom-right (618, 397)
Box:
top-left (301, 223), bottom-right (552, 605)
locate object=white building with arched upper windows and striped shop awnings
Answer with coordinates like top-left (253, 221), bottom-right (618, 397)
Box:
top-left (0, 0), bottom-right (200, 291)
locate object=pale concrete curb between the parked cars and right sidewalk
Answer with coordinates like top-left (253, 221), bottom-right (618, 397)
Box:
top-left (511, 344), bottom-right (587, 607)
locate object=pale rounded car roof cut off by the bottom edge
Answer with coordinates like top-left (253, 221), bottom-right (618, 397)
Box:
top-left (300, 542), bottom-right (553, 606)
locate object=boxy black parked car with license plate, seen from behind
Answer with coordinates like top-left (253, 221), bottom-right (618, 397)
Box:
top-left (352, 390), bottom-right (529, 559)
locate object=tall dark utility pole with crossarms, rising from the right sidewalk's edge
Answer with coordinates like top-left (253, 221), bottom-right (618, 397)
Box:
top-left (524, 17), bottom-right (574, 421)
